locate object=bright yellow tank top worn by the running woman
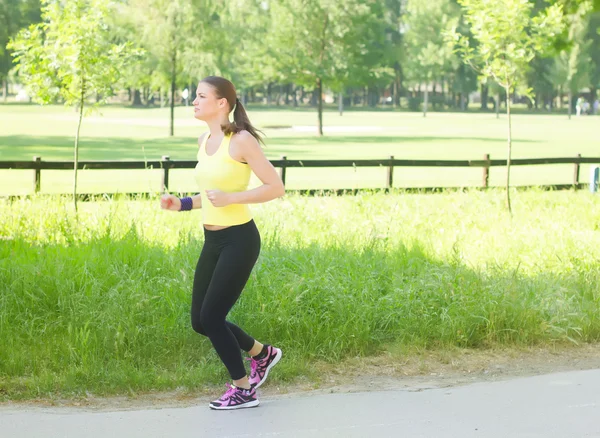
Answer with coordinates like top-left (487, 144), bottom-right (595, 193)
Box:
top-left (194, 134), bottom-right (252, 226)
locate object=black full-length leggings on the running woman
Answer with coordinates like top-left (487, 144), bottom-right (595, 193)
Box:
top-left (192, 220), bottom-right (260, 380)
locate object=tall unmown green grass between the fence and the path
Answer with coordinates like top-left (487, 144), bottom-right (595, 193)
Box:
top-left (0, 190), bottom-right (600, 399)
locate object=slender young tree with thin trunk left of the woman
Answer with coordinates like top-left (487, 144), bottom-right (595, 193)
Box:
top-left (9, 0), bottom-right (136, 211)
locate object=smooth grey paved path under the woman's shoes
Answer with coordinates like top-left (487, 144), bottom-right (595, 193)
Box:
top-left (0, 369), bottom-right (600, 438)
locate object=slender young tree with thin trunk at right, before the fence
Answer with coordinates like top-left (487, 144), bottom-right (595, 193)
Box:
top-left (448, 0), bottom-right (562, 214)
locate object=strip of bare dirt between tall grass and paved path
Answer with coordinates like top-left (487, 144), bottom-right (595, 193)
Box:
top-left (0, 344), bottom-right (600, 411)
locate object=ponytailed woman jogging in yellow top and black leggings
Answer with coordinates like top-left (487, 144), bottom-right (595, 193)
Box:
top-left (161, 76), bottom-right (285, 410)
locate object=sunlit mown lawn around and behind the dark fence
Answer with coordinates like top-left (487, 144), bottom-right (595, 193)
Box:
top-left (0, 105), bottom-right (600, 194)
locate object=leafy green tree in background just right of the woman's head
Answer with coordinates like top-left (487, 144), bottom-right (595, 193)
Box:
top-left (264, 0), bottom-right (383, 135)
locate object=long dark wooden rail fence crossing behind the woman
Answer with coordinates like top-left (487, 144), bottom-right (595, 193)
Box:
top-left (0, 154), bottom-right (600, 192)
